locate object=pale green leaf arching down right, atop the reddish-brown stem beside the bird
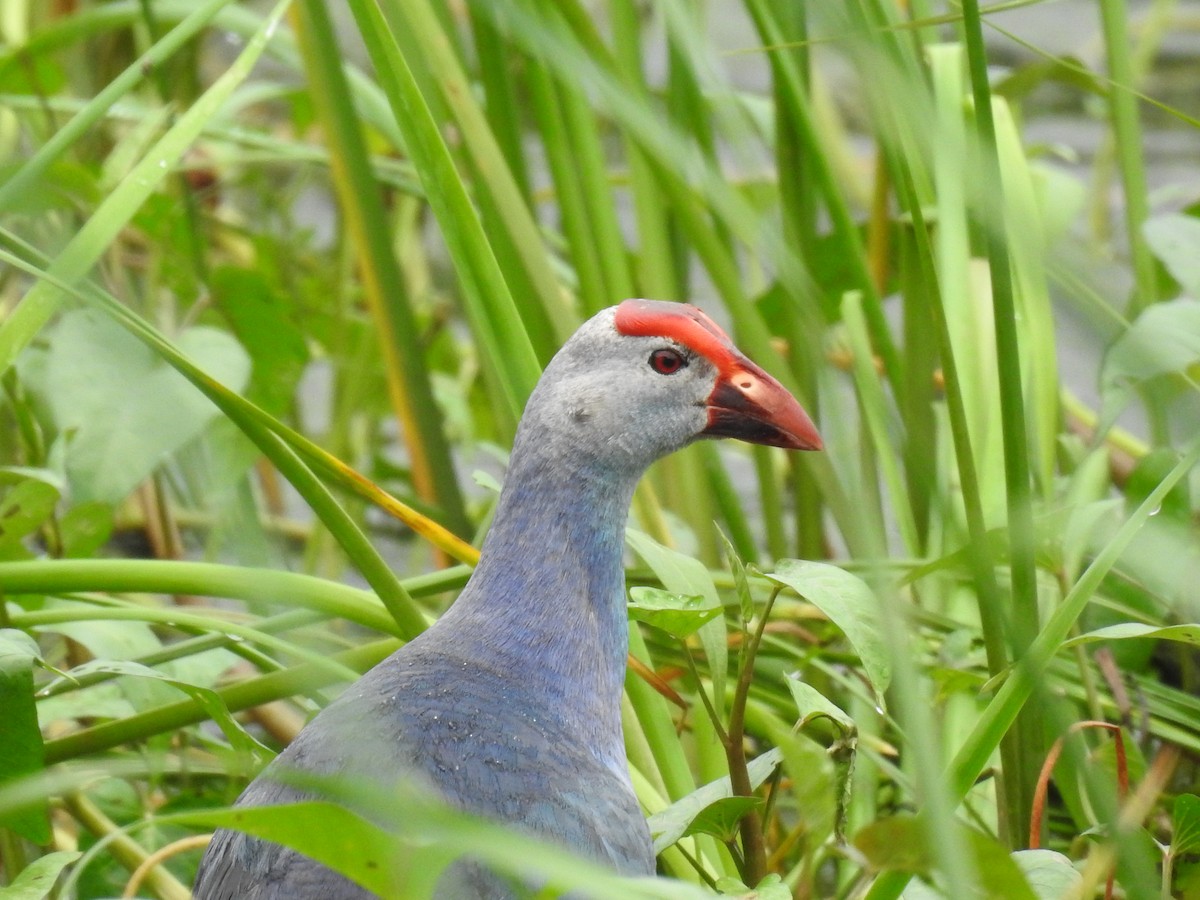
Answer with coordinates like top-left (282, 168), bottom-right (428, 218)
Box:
top-left (767, 559), bottom-right (892, 707)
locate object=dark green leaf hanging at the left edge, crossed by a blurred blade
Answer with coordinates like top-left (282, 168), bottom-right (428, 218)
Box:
top-left (0, 629), bottom-right (50, 844)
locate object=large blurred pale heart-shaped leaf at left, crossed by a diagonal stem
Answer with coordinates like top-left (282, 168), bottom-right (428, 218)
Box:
top-left (25, 310), bottom-right (250, 503)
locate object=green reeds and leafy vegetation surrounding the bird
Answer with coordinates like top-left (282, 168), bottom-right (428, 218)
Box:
top-left (0, 0), bottom-right (1200, 900)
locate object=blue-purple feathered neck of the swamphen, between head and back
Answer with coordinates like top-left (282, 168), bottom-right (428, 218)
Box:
top-left (439, 440), bottom-right (641, 764)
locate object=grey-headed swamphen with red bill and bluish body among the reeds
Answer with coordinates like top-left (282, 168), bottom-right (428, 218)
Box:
top-left (196, 300), bottom-right (821, 900)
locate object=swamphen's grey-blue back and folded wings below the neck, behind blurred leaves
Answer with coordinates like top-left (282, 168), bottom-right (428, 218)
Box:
top-left (196, 640), bottom-right (654, 900)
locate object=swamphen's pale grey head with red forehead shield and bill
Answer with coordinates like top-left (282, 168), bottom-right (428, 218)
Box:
top-left (522, 300), bottom-right (821, 470)
